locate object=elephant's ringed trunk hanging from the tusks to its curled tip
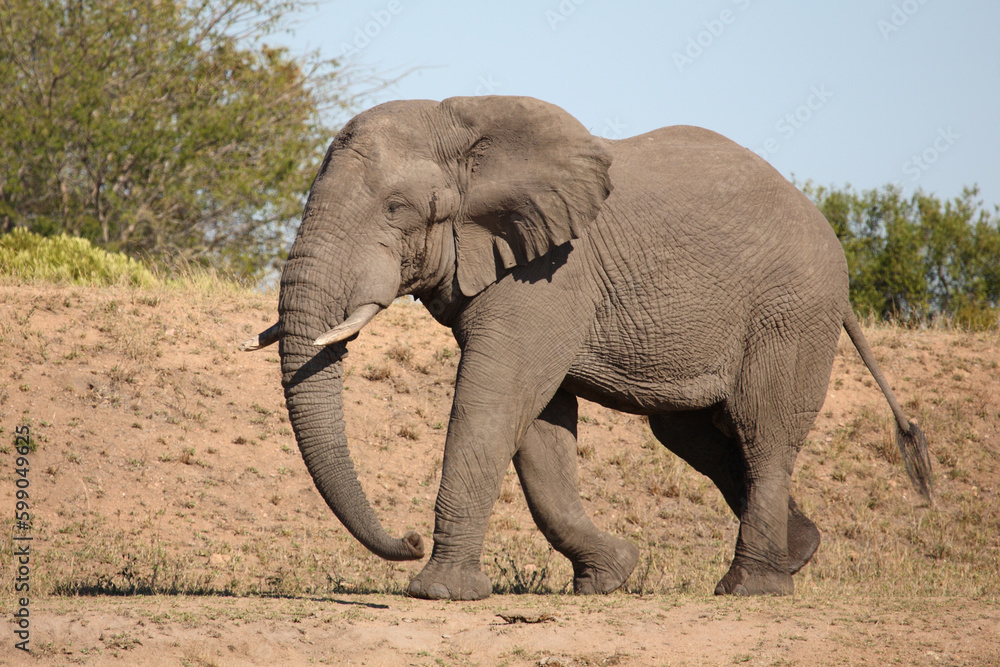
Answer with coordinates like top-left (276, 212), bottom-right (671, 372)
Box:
top-left (281, 302), bottom-right (424, 560)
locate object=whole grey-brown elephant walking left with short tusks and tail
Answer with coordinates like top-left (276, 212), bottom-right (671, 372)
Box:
top-left (242, 96), bottom-right (932, 600)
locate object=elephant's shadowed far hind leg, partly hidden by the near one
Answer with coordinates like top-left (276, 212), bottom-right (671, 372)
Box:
top-left (649, 407), bottom-right (820, 574)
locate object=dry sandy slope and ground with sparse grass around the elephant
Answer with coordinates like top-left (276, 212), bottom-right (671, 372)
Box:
top-left (0, 286), bottom-right (1000, 665)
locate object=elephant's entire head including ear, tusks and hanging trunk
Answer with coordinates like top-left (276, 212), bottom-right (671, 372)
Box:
top-left (244, 97), bottom-right (611, 560)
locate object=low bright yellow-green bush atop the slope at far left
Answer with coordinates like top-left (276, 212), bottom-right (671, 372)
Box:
top-left (0, 228), bottom-right (157, 287)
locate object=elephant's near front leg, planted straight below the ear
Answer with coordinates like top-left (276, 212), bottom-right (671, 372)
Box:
top-left (409, 282), bottom-right (593, 600)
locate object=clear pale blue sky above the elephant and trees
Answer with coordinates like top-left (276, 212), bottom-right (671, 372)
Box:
top-left (283, 0), bottom-right (1000, 210)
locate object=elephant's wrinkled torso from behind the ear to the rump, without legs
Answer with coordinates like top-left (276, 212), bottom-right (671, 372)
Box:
top-left (575, 126), bottom-right (848, 411)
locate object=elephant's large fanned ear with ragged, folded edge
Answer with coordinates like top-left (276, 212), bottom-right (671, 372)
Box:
top-left (441, 96), bottom-right (611, 296)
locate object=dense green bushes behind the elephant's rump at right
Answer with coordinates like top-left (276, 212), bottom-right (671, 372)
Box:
top-left (803, 183), bottom-right (1000, 329)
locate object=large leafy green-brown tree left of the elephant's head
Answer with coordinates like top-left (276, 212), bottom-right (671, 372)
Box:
top-left (0, 0), bottom-right (348, 275)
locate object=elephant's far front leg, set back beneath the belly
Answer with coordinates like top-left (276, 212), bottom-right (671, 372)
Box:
top-left (514, 390), bottom-right (639, 594)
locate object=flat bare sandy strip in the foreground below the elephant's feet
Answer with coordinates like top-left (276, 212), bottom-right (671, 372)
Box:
top-left (0, 595), bottom-right (1000, 666)
